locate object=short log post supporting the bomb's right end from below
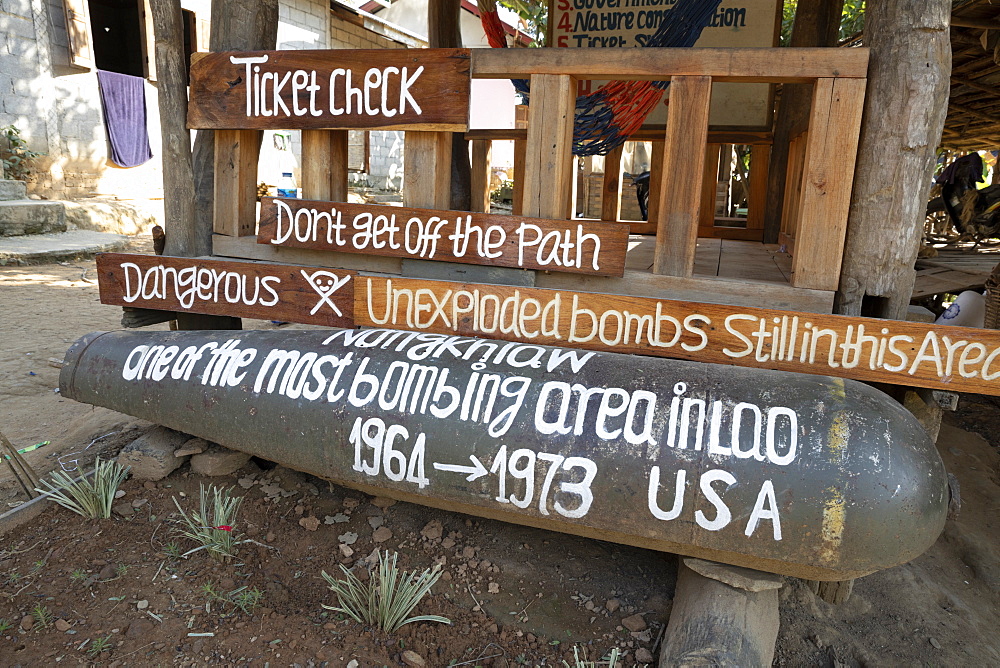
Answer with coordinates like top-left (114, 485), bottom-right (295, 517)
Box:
top-left (659, 557), bottom-right (782, 668)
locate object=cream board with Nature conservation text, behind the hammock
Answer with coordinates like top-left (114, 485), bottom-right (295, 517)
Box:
top-left (549, 0), bottom-right (780, 127)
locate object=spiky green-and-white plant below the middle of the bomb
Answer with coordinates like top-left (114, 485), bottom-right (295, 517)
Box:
top-left (322, 552), bottom-right (451, 633)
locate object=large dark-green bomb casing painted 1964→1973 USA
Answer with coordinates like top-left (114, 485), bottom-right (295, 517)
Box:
top-left (60, 329), bottom-right (947, 580)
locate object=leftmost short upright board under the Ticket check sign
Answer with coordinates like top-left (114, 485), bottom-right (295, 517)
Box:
top-left (213, 130), bottom-right (261, 237)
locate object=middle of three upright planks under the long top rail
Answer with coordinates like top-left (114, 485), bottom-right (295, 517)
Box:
top-left (652, 75), bottom-right (712, 276)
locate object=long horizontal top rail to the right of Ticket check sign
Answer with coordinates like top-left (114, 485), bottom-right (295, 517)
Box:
top-left (471, 47), bottom-right (868, 82)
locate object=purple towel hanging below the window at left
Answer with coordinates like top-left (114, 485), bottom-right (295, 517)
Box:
top-left (97, 70), bottom-right (153, 167)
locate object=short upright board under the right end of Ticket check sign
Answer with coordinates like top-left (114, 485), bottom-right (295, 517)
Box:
top-left (403, 131), bottom-right (452, 209)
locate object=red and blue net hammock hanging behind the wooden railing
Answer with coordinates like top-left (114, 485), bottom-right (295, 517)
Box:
top-left (479, 0), bottom-right (722, 156)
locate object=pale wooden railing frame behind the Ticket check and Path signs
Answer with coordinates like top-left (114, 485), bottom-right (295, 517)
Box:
top-left (213, 49), bottom-right (868, 313)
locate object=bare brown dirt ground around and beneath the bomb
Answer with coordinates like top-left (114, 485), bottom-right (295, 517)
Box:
top-left (0, 248), bottom-right (1000, 668)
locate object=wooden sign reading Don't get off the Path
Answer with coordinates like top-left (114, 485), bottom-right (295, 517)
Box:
top-left (257, 197), bottom-right (628, 276)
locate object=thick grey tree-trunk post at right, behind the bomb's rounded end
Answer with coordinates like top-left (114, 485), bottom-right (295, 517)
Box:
top-left (834, 0), bottom-right (951, 320)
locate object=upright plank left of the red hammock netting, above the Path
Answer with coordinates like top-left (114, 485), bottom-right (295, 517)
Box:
top-left (523, 74), bottom-right (576, 218)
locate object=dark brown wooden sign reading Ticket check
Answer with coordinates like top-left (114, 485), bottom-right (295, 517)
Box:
top-left (188, 49), bottom-right (470, 132)
